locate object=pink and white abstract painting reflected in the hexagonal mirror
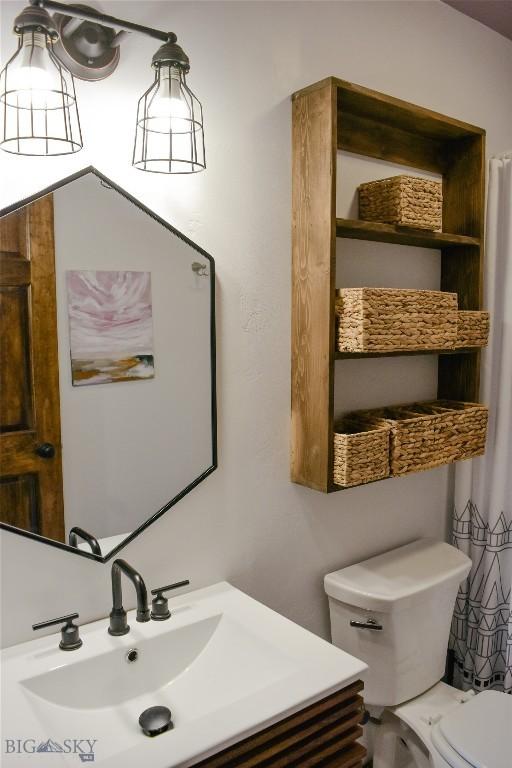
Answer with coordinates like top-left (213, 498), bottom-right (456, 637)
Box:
top-left (66, 270), bottom-right (155, 386)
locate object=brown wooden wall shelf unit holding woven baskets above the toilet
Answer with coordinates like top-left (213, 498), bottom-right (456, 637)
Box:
top-left (291, 77), bottom-right (485, 492)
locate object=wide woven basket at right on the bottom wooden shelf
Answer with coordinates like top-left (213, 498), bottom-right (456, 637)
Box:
top-left (355, 400), bottom-right (488, 476)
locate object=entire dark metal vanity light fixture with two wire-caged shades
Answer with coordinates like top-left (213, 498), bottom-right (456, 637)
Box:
top-left (0, 0), bottom-right (206, 173)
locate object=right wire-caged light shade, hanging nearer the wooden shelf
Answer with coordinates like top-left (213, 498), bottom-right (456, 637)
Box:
top-left (133, 42), bottom-right (206, 173)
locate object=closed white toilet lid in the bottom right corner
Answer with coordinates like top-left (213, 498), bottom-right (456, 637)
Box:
top-left (431, 691), bottom-right (512, 768)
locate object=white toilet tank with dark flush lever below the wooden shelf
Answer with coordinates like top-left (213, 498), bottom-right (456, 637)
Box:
top-left (324, 539), bottom-right (471, 706)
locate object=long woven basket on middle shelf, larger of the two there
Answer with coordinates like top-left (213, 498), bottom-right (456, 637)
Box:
top-left (336, 288), bottom-right (457, 352)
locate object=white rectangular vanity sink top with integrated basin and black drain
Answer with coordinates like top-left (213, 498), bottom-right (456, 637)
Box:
top-left (1, 583), bottom-right (366, 768)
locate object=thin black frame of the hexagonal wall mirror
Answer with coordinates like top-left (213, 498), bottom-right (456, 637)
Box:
top-left (0, 165), bottom-right (218, 563)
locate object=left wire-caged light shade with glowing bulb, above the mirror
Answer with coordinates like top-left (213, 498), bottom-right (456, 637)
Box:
top-left (0, 7), bottom-right (82, 155)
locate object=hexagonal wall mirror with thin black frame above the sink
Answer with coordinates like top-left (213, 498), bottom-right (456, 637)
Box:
top-left (0, 168), bottom-right (217, 562)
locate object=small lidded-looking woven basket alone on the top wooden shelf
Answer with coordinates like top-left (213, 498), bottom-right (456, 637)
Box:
top-left (359, 176), bottom-right (443, 231)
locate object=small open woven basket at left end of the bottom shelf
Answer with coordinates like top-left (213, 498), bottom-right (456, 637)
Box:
top-left (333, 418), bottom-right (390, 488)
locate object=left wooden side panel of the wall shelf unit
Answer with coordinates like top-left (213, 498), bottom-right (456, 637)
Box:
top-left (291, 82), bottom-right (337, 492)
